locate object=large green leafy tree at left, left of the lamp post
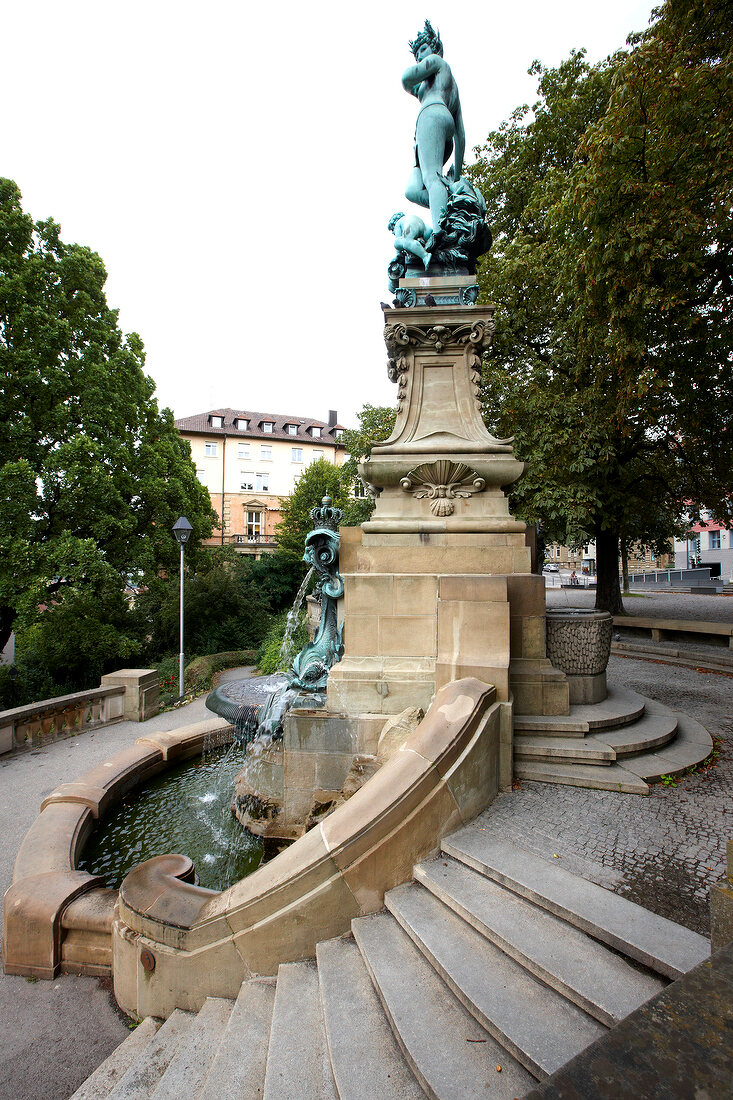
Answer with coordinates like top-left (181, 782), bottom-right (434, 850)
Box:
top-left (0, 179), bottom-right (215, 666)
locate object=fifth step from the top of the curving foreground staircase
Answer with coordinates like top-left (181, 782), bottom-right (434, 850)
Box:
top-left (316, 936), bottom-right (425, 1100)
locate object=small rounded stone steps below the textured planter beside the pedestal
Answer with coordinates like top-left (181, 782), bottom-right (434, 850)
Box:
top-left (514, 684), bottom-right (712, 794)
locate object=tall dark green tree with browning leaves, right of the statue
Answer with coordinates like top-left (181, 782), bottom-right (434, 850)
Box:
top-left (468, 0), bottom-right (733, 612)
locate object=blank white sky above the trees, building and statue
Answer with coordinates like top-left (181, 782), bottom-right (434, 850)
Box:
top-left (0, 0), bottom-right (654, 425)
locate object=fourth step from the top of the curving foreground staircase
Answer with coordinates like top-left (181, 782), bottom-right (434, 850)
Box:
top-left (351, 913), bottom-right (535, 1100)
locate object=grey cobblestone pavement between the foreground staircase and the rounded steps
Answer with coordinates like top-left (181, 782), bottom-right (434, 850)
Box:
top-left (473, 651), bottom-right (733, 935)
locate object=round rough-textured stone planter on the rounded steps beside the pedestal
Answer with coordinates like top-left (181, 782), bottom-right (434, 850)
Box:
top-left (547, 607), bottom-right (613, 703)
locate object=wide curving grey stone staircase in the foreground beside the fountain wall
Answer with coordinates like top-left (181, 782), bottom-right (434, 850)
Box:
top-left (73, 824), bottom-right (710, 1100)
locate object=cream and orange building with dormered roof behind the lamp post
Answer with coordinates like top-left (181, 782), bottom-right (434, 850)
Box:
top-left (176, 408), bottom-right (346, 558)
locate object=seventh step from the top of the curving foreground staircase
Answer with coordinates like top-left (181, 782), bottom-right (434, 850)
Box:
top-left (198, 978), bottom-right (275, 1100)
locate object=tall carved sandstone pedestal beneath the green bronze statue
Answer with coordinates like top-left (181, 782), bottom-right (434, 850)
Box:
top-left (328, 292), bottom-right (569, 785)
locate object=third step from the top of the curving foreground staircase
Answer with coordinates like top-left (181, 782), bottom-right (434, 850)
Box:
top-left (384, 882), bottom-right (605, 1078)
